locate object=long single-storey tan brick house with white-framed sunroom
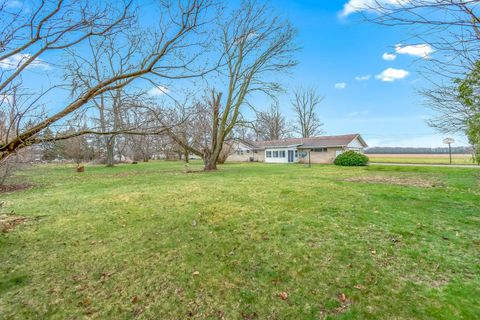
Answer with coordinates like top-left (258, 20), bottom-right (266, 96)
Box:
top-left (227, 134), bottom-right (368, 163)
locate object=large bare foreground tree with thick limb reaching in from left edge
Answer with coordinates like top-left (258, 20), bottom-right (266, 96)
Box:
top-left (0, 0), bottom-right (211, 165)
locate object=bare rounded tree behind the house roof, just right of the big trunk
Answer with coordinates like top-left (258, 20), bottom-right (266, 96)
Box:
top-left (253, 101), bottom-right (290, 140)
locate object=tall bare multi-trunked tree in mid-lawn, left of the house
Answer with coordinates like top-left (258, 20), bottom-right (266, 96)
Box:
top-left (167, 0), bottom-right (297, 171)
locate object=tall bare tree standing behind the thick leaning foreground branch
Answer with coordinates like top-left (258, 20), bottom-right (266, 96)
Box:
top-left (65, 32), bottom-right (143, 166)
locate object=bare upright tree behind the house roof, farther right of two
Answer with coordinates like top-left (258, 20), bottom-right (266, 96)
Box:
top-left (292, 88), bottom-right (324, 138)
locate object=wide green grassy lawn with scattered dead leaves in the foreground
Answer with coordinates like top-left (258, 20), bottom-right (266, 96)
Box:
top-left (0, 162), bottom-right (480, 319)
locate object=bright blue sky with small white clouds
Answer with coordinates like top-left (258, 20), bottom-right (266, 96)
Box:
top-left (0, 0), bottom-right (468, 147)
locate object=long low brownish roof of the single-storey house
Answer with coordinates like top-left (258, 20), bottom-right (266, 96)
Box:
top-left (250, 134), bottom-right (368, 149)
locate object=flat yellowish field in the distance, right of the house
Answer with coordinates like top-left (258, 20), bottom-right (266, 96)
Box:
top-left (367, 154), bottom-right (473, 164)
